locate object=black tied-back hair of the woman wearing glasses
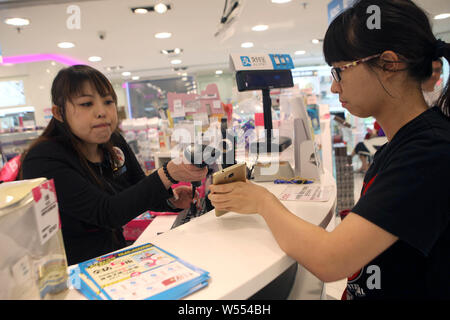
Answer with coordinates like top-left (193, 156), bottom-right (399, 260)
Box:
top-left (323, 0), bottom-right (450, 116)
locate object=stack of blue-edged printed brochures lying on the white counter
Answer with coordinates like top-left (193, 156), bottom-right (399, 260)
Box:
top-left (71, 243), bottom-right (209, 300)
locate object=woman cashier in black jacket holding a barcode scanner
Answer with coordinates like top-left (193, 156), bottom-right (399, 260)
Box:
top-left (22, 65), bottom-right (207, 264)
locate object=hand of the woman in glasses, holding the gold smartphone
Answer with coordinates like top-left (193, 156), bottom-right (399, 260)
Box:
top-left (208, 181), bottom-right (273, 213)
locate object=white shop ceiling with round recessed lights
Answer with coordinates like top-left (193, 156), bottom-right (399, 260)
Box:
top-left (0, 0), bottom-right (450, 77)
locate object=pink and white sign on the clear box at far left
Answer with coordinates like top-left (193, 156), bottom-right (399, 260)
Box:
top-left (32, 180), bottom-right (59, 245)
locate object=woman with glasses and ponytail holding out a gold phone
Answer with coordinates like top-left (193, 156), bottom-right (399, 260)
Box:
top-left (209, 0), bottom-right (450, 299)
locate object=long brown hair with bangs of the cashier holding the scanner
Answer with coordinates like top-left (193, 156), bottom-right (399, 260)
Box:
top-left (20, 65), bottom-right (118, 187)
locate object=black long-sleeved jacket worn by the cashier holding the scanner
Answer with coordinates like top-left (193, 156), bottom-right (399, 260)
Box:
top-left (22, 134), bottom-right (178, 265)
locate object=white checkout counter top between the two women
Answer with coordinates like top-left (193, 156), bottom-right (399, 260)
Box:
top-left (53, 170), bottom-right (336, 300)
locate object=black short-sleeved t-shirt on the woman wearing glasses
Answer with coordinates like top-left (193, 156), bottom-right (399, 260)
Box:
top-left (343, 107), bottom-right (450, 299)
